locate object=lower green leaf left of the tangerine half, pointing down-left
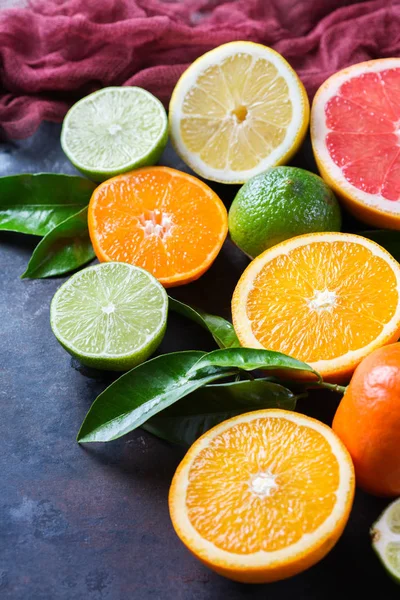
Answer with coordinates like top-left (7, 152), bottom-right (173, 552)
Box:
top-left (21, 208), bottom-right (95, 279)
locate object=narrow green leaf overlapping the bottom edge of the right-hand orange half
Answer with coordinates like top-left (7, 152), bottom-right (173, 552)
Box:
top-left (188, 348), bottom-right (321, 379)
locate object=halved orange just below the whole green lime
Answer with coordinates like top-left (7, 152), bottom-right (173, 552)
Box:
top-left (232, 233), bottom-right (400, 381)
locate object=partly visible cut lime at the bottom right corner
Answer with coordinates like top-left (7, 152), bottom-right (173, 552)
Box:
top-left (371, 498), bottom-right (400, 583)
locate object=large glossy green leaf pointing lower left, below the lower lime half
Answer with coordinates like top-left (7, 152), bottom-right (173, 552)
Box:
top-left (77, 350), bottom-right (236, 442)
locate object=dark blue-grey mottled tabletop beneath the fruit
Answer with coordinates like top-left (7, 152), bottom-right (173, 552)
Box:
top-left (0, 124), bottom-right (399, 600)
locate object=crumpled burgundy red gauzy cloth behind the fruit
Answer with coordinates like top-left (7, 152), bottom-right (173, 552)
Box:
top-left (0, 0), bottom-right (400, 138)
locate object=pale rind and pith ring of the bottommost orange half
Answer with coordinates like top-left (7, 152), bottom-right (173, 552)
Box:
top-left (171, 409), bottom-right (354, 569)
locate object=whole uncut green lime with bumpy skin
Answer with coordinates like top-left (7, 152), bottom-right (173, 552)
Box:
top-left (229, 167), bottom-right (341, 258)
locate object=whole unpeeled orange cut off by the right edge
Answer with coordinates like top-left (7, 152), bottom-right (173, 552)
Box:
top-left (332, 343), bottom-right (400, 496)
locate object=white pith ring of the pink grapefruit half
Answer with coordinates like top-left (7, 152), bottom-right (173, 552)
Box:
top-left (310, 58), bottom-right (400, 215)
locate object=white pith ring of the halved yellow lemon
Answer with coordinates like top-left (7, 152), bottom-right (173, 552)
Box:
top-left (169, 42), bottom-right (306, 183)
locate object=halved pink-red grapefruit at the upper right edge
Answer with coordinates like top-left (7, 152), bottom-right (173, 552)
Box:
top-left (311, 58), bottom-right (400, 229)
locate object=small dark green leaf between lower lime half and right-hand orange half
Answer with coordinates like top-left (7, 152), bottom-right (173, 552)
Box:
top-left (169, 297), bottom-right (240, 348)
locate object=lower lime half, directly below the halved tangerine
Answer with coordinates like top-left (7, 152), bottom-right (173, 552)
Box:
top-left (50, 263), bottom-right (168, 371)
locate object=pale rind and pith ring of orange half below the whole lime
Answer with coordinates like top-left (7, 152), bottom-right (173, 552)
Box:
top-left (234, 233), bottom-right (400, 375)
